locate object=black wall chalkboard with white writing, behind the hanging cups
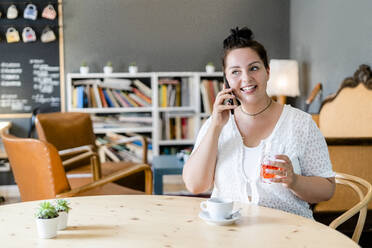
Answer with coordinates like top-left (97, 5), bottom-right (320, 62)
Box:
top-left (0, 0), bottom-right (61, 114)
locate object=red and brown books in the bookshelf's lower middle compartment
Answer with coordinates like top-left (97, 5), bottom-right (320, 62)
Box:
top-left (159, 113), bottom-right (195, 140)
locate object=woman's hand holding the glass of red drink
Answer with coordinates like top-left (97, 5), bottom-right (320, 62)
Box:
top-left (270, 154), bottom-right (297, 189)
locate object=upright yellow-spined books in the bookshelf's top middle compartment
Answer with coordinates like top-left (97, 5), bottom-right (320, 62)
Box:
top-left (159, 78), bottom-right (192, 107)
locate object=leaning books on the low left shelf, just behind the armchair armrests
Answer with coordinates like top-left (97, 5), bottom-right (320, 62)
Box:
top-left (97, 133), bottom-right (153, 163)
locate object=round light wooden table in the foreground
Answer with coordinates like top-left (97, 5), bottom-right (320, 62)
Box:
top-left (0, 195), bottom-right (359, 248)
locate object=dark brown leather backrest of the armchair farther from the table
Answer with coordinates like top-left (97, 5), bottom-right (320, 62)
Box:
top-left (36, 112), bottom-right (96, 151)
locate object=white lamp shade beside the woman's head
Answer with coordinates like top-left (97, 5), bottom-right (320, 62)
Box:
top-left (267, 59), bottom-right (300, 97)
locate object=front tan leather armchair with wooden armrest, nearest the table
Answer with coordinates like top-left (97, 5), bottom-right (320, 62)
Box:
top-left (3, 134), bottom-right (151, 201)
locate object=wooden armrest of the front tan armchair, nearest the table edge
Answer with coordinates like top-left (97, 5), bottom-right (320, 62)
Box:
top-left (56, 164), bottom-right (152, 198)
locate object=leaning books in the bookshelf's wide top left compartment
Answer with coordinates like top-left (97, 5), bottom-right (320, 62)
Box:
top-left (72, 78), bottom-right (152, 108)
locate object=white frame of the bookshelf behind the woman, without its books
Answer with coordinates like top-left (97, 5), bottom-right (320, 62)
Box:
top-left (66, 72), bottom-right (223, 155)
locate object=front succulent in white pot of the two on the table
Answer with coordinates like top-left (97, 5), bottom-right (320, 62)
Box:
top-left (35, 201), bottom-right (59, 239)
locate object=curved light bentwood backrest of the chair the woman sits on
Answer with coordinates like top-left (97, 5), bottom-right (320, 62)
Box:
top-left (329, 173), bottom-right (372, 243)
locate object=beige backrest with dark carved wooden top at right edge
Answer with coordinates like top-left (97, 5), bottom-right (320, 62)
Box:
top-left (319, 65), bottom-right (372, 138)
